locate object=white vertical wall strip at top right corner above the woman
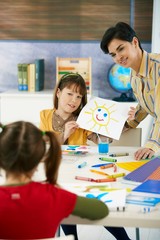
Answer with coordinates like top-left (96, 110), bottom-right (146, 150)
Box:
top-left (151, 0), bottom-right (160, 53)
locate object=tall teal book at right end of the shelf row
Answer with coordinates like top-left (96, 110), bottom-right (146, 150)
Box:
top-left (35, 59), bottom-right (44, 91)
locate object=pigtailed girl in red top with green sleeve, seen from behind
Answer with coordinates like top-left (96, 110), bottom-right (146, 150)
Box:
top-left (0, 121), bottom-right (108, 239)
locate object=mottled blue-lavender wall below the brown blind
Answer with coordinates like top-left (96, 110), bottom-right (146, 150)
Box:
top-left (0, 40), bottom-right (151, 99)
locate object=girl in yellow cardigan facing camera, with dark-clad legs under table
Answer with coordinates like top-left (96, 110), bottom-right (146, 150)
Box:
top-left (40, 73), bottom-right (132, 240)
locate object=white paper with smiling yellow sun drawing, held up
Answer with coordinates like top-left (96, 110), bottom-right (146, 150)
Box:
top-left (77, 97), bottom-right (129, 140)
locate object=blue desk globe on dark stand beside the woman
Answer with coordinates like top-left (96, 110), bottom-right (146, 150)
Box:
top-left (108, 64), bottom-right (135, 102)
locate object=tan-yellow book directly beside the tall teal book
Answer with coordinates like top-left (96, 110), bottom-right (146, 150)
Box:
top-left (28, 63), bottom-right (36, 92)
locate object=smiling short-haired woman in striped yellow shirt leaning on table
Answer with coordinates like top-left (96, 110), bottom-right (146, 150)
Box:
top-left (101, 22), bottom-right (160, 160)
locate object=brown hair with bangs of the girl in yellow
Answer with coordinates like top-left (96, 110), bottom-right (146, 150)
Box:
top-left (53, 73), bottom-right (87, 116)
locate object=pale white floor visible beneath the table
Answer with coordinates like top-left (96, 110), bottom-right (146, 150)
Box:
top-left (61, 225), bottom-right (160, 240)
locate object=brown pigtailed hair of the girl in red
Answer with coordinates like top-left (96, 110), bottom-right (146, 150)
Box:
top-left (0, 121), bottom-right (61, 184)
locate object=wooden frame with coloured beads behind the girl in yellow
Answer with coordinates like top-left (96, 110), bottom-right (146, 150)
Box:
top-left (56, 57), bottom-right (92, 95)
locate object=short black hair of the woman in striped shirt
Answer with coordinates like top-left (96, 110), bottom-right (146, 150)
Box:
top-left (100, 22), bottom-right (142, 54)
